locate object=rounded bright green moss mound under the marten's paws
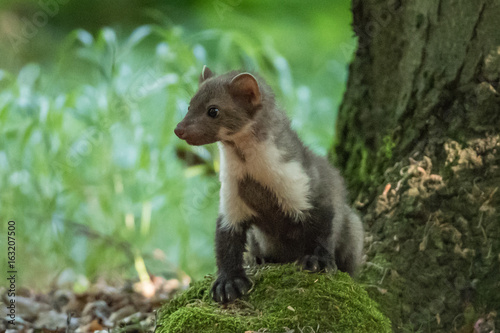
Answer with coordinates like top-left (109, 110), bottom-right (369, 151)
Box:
top-left (157, 265), bottom-right (391, 333)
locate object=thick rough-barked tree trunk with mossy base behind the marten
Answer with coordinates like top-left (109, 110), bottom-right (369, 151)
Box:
top-left (332, 0), bottom-right (500, 332)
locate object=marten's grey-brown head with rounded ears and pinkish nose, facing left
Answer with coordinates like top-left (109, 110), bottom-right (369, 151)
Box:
top-left (174, 66), bottom-right (262, 146)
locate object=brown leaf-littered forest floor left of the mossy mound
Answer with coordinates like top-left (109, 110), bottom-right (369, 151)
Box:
top-left (0, 276), bottom-right (186, 333)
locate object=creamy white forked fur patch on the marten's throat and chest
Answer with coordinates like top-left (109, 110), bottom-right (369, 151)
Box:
top-left (219, 133), bottom-right (312, 227)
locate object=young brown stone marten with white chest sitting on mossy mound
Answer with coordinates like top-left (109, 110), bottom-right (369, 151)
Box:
top-left (175, 66), bottom-right (363, 303)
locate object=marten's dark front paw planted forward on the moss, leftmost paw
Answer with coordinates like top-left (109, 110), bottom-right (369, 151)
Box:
top-left (212, 273), bottom-right (252, 304)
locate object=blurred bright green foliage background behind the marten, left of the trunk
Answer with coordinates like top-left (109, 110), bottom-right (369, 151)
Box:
top-left (0, 0), bottom-right (355, 289)
